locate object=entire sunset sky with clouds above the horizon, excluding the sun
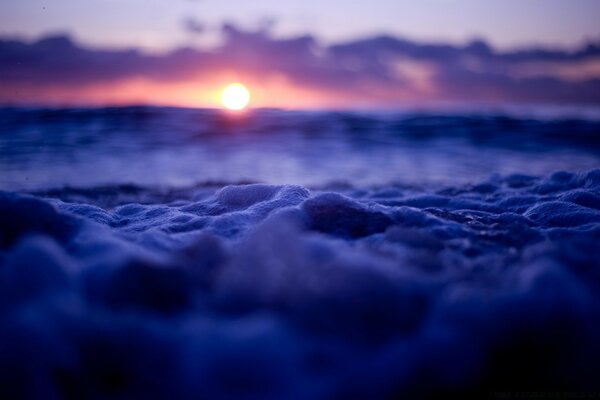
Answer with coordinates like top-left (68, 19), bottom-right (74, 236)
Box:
top-left (0, 0), bottom-right (600, 108)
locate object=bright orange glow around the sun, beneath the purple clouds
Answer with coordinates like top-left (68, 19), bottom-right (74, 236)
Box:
top-left (0, 71), bottom-right (404, 109)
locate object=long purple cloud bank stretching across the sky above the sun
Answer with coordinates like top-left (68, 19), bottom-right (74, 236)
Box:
top-left (0, 23), bottom-right (600, 106)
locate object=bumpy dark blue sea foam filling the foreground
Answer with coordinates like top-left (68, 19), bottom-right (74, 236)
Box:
top-left (0, 170), bottom-right (600, 399)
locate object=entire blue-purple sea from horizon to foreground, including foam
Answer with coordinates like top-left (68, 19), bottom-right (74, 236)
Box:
top-left (0, 107), bottom-right (600, 399)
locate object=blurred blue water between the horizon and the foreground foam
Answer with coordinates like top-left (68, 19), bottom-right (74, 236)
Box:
top-left (0, 107), bottom-right (600, 190)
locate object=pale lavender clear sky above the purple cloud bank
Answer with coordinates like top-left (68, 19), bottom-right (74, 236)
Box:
top-left (0, 0), bottom-right (600, 49)
